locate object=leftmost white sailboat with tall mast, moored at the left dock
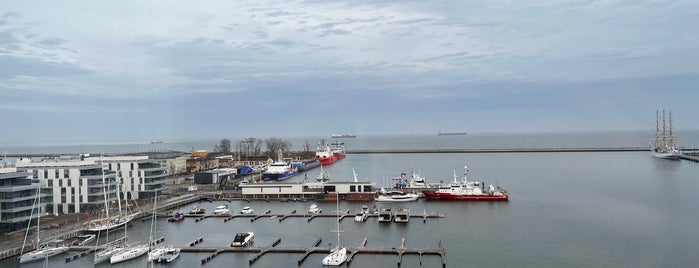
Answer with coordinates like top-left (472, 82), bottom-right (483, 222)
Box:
top-left (19, 187), bottom-right (68, 263)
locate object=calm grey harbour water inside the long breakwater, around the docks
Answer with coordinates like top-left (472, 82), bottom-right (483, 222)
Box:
top-left (0, 135), bottom-right (699, 267)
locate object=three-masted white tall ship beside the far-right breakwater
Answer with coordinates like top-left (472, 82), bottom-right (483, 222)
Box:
top-left (650, 110), bottom-right (682, 160)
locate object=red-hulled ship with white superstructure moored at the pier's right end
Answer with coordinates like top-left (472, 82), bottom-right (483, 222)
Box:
top-left (422, 166), bottom-right (510, 201)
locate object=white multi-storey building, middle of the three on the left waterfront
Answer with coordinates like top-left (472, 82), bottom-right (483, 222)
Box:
top-left (16, 158), bottom-right (116, 215)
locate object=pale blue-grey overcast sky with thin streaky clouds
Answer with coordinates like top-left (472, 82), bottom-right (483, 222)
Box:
top-left (0, 0), bottom-right (699, 144)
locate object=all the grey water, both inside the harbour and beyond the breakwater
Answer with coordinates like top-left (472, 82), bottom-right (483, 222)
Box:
top-left (0, 131), bottom-right (699, 268)
